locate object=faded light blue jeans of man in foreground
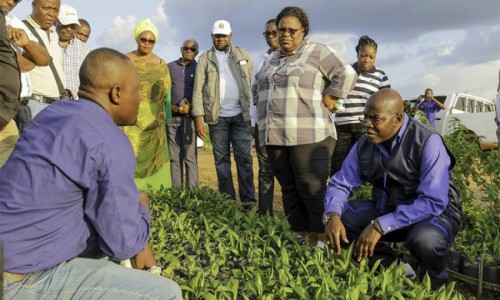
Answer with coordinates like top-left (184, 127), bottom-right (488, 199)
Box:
top-left (3, 258), bottom-right (182, 300)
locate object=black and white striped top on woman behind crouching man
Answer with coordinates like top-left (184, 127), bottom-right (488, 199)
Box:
top-left (335, 63), bottom-right (391, 125)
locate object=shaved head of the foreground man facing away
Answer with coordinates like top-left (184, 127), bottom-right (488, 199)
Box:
top-left (78, 48), bottom-right (140, 125)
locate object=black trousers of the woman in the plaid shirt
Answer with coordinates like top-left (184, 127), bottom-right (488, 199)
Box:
top-left (267, 137), bottom-right (335, 233)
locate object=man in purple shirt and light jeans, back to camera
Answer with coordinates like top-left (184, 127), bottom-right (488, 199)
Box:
top-left (0, 48), bottom-right (182, 299)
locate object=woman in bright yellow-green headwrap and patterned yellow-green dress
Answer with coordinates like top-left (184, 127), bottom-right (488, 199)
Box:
top-left (123, 19), bottom-right (171, 190)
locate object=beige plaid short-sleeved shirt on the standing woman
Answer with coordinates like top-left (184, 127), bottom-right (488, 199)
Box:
top-left (255, 40), bottom-right (356, 146)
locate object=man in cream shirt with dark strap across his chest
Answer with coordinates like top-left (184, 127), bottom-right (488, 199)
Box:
top-left (24, 0), bottom-right (69, 117)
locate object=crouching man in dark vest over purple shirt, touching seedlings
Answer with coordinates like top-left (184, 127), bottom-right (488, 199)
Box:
top-left (323, 89), bottom-right (461, 288)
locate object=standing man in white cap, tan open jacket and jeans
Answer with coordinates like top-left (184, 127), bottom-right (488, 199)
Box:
top-left (192, 20), bottom-right (256, 209)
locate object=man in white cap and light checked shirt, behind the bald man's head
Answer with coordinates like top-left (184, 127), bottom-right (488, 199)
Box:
top-left (56, 4), bottom-right (90, 99)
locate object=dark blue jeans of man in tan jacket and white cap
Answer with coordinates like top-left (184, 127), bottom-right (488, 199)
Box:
top-left (209, 114), bottom-right (255, 203)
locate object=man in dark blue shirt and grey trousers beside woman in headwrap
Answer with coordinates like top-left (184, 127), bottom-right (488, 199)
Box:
top-left (167, 39), bottom-right (198, 189)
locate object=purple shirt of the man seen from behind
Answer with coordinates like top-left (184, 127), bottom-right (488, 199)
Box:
top-left (0, 99), bottom-right (150, 273)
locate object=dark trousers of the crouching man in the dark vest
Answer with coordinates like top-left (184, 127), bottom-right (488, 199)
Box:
top-left (341, 200), bottom-right (460, 289)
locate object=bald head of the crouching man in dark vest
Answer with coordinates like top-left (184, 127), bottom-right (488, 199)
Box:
top-left (363, 89), bottom-right (405, 146)
